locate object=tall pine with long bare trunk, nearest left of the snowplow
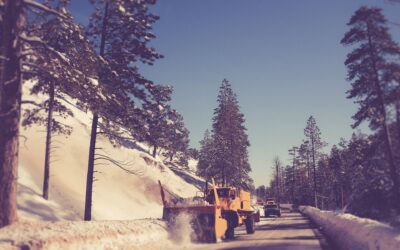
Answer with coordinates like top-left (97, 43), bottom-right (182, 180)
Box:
top-left (85, 0), bottom-right (161, 220)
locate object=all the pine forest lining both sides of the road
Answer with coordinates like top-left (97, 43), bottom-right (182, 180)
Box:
top-left (0, 0), bottom-right (400, 232)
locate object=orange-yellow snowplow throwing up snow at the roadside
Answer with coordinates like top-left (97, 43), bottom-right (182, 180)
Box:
top-left (159, 179), bottom-right (260, 242)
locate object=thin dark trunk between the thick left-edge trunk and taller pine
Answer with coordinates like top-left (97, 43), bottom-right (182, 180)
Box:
top-left (43, 82), bottom-right (54, 200)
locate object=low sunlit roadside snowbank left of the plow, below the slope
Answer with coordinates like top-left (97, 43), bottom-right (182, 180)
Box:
top-left (0, 219), bottom-right (184, 250)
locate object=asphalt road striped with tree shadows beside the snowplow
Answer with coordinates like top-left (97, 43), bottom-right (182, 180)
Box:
top-left (193, 213), bottom-right (333, 250)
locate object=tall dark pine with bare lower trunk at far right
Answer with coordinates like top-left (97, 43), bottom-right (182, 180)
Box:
top-left (341, 7), bottom-right (400, 211)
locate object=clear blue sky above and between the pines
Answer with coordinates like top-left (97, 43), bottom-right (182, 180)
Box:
top-left (72, 0), bottom-right (400, 186)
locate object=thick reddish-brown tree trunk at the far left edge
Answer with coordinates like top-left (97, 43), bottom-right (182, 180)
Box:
top-left (0, 0), bottom-right (24, 227)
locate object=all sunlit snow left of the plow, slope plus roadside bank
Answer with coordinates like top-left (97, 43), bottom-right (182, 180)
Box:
top-left (0, 85), bottom-right (206, 249)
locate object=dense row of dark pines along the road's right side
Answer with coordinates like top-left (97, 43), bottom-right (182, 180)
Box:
top-left (260, 6), bottom-right (400, 220)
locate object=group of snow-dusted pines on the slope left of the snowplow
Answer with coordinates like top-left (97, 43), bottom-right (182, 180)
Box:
top-left (0, 0), bottom-right (189, 227)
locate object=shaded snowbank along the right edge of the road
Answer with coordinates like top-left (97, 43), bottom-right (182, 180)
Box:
top-left (300, 206), bottom-right (400, 250)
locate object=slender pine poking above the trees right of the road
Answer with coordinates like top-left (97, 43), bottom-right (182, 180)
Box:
top-left (304, 116), bottom-right (325, 207)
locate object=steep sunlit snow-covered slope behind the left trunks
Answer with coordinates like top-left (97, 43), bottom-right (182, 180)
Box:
top-left (18, 91), bottom-right (202, 220)
